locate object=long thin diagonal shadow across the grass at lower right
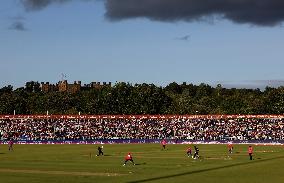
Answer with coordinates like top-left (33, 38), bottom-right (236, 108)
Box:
top-left (128, 156), bottom-right (284, 183)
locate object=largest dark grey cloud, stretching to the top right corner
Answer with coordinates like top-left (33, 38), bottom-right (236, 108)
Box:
top-left (105, 0), bottom-right (284, 26)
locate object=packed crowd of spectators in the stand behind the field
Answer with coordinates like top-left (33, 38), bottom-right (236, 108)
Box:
top-left (0, 118), bottom-right (284, 141)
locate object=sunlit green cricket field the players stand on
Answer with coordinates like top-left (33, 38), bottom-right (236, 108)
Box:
top-left (0, 144), bottom-right (284, 183)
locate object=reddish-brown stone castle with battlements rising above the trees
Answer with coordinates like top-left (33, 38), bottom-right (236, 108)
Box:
top-left (41, 80), bottom-right (111, 93)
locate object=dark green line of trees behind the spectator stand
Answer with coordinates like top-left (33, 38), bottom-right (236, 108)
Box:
top-left (0, 81), bottom-right (284, 114)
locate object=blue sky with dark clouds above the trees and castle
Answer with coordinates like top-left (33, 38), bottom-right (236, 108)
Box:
top-left (0, 0), bottom-right (284, 89)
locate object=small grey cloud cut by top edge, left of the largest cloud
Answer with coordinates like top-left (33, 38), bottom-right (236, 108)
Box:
top-left (21, 0), bottom-right (72, 11)
